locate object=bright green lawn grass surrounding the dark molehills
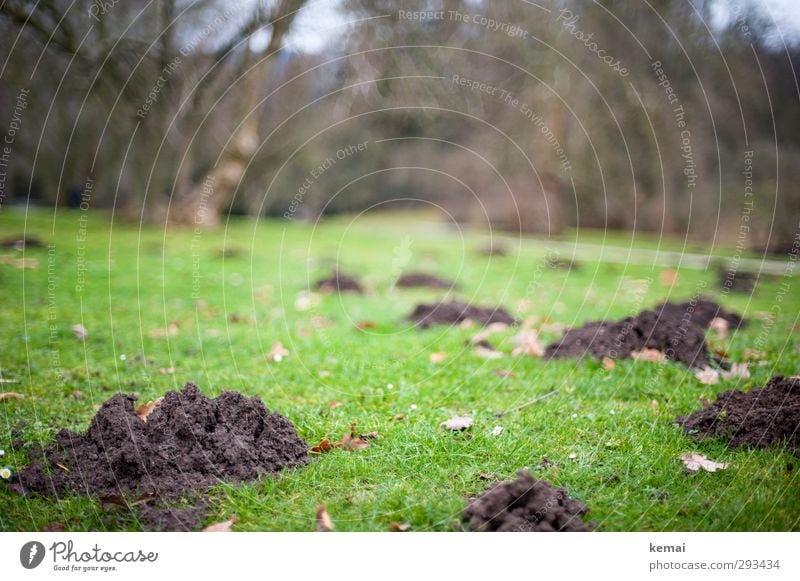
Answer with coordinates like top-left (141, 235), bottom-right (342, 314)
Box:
top-left (0, 209), bottom-right (800, 531)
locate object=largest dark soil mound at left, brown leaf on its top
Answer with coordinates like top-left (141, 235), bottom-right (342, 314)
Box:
top-left (13, 383), bottom-right (308, 498)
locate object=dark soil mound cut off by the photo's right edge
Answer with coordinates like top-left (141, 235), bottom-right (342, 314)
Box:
top-left (675, 375), bottom-right (800, 456)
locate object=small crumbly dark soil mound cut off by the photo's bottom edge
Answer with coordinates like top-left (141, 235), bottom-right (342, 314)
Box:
top-left (464, 470), bottom-right (589, 532)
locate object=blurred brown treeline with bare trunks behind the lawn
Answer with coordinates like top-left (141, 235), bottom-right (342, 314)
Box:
top-left (0, 0), bottom-right (800, 251)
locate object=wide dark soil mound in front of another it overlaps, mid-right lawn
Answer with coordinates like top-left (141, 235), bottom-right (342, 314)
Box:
top-left (545, 310), bottom-right (709, 367)
